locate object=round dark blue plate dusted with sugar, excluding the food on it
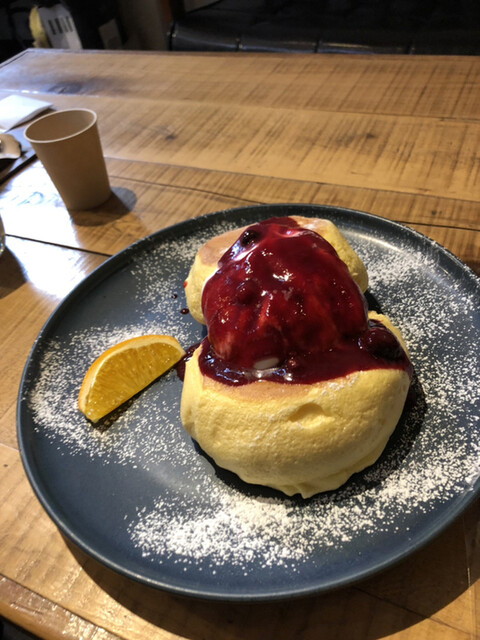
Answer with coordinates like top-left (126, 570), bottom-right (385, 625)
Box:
top-left (18, 205), bottom-right (480, 600)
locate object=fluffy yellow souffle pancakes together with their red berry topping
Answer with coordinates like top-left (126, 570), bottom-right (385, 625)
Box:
top-left (180, 217), bottom-right (412, 498)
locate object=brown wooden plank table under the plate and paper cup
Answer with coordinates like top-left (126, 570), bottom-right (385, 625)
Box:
top-left (0, 50), bottom-right (480, 640)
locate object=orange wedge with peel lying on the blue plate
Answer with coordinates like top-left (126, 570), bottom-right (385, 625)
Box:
top-left (78, 335), bottom-right (185, 422)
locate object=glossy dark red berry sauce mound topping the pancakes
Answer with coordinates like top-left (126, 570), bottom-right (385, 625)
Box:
top-left (199, 218), bottom-right (410, 384)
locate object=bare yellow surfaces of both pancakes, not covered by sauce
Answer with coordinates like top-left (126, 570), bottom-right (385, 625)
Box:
top-left (180, 217), bottom-right (410, 498)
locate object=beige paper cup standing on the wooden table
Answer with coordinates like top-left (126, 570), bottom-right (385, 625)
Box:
top-left (24, 109), bottom-right (111, 210)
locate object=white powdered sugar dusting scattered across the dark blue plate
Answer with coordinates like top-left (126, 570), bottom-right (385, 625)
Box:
top-left (23, 211), bottom-right (480, 596)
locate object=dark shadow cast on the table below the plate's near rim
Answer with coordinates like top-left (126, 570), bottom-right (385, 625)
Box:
top-left (67, 501), bottom-right (479, 640)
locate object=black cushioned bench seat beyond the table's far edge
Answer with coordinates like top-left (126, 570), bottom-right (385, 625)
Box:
top-left (170, 0), bottom-right (480, 55)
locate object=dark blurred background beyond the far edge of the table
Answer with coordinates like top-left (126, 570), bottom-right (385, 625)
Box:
top-left (0, 0), bottom-right (480, 61)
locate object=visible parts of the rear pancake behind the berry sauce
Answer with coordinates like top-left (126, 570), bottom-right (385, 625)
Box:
top-left (185, 216), bottom-right (368, 324)
